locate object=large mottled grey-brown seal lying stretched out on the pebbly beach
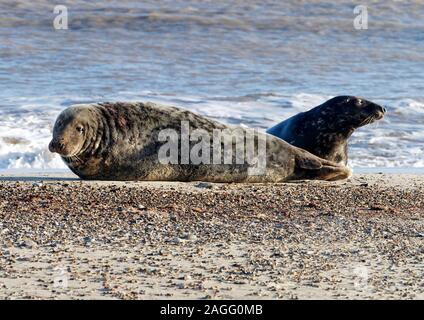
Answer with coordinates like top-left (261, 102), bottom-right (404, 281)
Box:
top-left (49, 102), bottom-right (351, 182)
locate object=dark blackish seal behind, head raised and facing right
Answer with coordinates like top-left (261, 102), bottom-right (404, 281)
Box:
top-left (267, 96), bottom-right (386, 165)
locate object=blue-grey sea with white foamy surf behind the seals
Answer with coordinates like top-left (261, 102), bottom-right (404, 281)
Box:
top-left (0, 0), bottom-right (424, 169)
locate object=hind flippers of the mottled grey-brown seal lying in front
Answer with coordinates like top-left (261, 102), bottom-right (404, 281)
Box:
top-left (294, 152), bottom-right (352, 181)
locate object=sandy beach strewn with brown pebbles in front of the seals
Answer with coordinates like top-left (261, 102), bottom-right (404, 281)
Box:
top-left (0, 173), bottom-right (424, 299)
